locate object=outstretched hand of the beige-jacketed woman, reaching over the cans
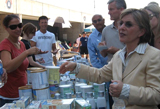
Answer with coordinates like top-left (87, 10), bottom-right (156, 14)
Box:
top-left (59, 62), bottom-right (77, 74)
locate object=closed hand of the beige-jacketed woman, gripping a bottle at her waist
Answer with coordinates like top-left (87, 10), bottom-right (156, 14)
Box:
top-left (109, 80), bottom-right (123, 97)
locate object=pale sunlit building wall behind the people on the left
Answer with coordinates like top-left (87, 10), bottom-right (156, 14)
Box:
top-left (0, 0), bottom-right (92, 42)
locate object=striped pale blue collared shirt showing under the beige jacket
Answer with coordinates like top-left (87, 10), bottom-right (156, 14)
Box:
top-left (118, 43), bottom-right (148, 99)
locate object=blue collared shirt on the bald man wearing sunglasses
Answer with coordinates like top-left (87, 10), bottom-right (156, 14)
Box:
top-left (87, 29), bottom-right (107, 68)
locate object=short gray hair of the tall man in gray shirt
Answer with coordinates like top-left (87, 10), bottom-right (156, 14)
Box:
top-left (107, 0), bottom-right (127, 9)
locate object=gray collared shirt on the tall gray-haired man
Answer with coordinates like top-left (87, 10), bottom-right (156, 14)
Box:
top-left (102, 22), bottom-right (125, 62)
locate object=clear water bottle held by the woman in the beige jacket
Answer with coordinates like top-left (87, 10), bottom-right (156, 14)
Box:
top-left (112, 82), bottom-right (125, 109)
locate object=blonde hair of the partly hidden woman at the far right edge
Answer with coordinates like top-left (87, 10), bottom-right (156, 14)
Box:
top-left (144, 4), bottom-right (160, 38)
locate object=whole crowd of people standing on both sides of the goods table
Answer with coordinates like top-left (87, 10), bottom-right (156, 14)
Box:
top-left (0, 0), bottom-right (160, 109)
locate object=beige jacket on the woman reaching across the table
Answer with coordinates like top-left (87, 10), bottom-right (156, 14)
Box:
top-left (77, 45), bottom-right (160, 109)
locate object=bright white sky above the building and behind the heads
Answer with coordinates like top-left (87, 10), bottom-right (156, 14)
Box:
top-left (33, 0), bottom-right (160, 24)
